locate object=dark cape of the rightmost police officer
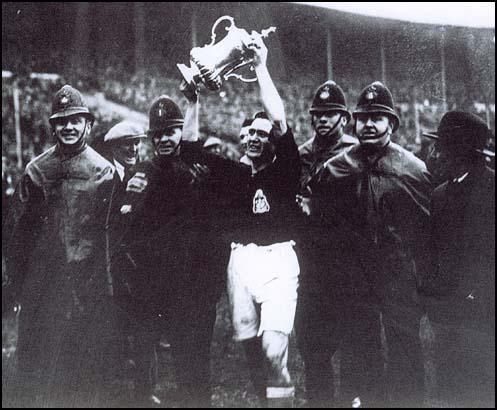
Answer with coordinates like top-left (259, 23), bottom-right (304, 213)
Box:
top-left (310, 142), bottom-right (431, 304)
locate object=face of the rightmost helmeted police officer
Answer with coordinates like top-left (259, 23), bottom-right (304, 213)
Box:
top-left (355, 113), bottom-right (392, 148)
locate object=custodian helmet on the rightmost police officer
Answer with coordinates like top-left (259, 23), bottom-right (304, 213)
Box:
top-left (352, 81), bottom-right (400, 132)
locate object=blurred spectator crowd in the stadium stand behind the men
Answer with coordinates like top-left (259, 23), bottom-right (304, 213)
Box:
top-left (2, 52), bottom-right (495, 193)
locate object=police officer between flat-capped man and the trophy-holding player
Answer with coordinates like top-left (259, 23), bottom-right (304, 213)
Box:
top-left (118, 96), bottom-right (192, 405)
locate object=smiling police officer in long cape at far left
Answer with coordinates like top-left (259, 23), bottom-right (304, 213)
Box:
top-left (3, 85), bottom-right (121, 407)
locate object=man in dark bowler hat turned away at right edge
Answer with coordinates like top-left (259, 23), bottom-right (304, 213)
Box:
top-left (422, 111), bottom-right (495, 407)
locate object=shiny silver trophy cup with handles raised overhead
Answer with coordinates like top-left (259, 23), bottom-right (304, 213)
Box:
top-left (177, 16), bottom-right (276, 91)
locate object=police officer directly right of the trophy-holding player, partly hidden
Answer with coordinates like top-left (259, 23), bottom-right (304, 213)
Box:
top-left (296, 81), bottom-right (377, 407)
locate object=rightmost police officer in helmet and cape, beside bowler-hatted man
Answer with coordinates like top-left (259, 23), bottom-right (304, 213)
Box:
top-left (311, 82), bottom-right (431, 406)
